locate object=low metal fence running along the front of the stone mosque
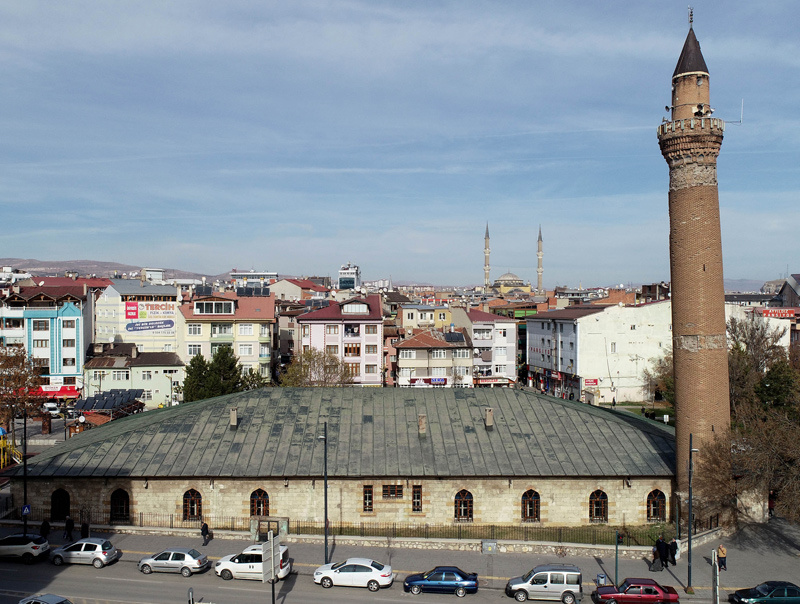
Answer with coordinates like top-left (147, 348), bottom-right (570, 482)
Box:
top-left (7, 507), bottom-right (680, 546)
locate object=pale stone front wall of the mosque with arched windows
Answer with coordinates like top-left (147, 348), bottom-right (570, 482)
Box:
top-left (12, 477), bottom-right (672, 526)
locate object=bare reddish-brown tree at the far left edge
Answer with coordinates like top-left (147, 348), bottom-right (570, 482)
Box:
top-left (0, 346), bottom-right (42, 440)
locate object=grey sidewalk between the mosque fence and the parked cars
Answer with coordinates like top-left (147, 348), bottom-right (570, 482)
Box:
top-left (0, 519), bottom-right (800, 602)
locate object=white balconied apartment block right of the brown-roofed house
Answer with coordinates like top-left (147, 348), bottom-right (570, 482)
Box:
top-left (451, 307), bottom-right (517, 387)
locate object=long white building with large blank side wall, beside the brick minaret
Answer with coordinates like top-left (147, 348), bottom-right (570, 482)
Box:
top-left (527, 300), bottom-right (789, 403)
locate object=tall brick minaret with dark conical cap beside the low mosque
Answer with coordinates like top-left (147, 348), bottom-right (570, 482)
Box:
top-left (658, 15), bottom-right (730, 499)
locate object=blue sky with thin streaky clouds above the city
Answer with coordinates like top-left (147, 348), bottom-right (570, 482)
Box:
top-left (0, 0), bottom-right (800, 287)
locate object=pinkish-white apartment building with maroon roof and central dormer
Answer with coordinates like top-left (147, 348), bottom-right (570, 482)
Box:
top-left (297, 294), bottom-right (384, 386)
